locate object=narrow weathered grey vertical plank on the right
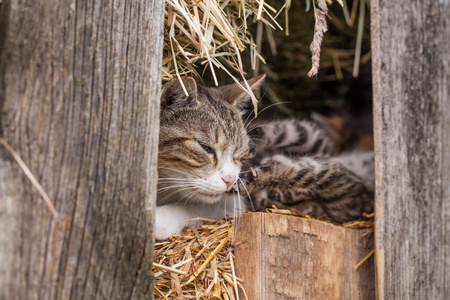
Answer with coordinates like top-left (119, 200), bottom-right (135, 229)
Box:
top-left (371, 0), bottom-right (450, 299)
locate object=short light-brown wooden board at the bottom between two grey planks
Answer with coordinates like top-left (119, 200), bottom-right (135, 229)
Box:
top-left (235, 213), bottom-right (375, 300)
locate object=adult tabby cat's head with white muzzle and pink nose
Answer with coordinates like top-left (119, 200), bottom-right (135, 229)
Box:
top-left (158, 75), bottom-right (265, 204)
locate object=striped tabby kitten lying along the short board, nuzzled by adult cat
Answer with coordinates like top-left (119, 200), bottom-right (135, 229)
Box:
top-left (240, 151), bottom-right (374, 223)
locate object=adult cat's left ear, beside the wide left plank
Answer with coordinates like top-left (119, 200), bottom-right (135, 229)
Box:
top-left (161, 77), bottom-right (197, 108)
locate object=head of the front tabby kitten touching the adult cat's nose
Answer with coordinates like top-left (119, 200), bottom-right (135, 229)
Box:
top-left (239, 155), bottom-right (324, 217)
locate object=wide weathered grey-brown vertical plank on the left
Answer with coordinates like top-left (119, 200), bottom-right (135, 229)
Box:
top-left (0, 0), bottom-right (164, 299)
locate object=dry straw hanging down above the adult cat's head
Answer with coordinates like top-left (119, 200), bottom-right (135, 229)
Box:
top-left (162, 0), bottom-right (356, 110)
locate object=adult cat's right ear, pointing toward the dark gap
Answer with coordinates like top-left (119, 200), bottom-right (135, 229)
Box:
top-left (217, 74), bottom-right (266, 109)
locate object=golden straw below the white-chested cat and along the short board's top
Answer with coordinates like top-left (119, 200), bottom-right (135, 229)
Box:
top-left (153, 207), bottom-right (374, 299)
